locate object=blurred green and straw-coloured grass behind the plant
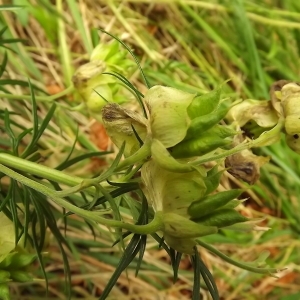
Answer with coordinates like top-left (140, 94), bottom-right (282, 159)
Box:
top-left (0, 0), bottom-right (300, 300)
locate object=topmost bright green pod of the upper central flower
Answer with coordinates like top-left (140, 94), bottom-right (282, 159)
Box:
top-left (187, 88), bottom-right (221, 120)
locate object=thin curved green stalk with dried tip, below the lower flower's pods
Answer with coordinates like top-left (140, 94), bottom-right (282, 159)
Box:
top-left (196, 239), bottom-right (279, 274)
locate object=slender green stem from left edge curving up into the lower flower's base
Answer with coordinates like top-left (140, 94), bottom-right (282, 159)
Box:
top-left (0, 164), bottom-right (163, 234)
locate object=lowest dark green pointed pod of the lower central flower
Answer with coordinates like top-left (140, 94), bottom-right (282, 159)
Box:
top-left (193, 209), bottom-right (248, 228)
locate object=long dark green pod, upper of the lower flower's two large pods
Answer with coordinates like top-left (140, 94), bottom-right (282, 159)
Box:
top-left (188, 190), bottom-right (242, 219)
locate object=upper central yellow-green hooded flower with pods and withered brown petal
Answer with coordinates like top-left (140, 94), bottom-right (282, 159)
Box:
top-left (102, 86), bottom-right (236, 172)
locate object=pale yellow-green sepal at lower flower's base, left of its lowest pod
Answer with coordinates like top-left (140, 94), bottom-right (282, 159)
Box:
top-left (163, 213), bottom-right (218, 238)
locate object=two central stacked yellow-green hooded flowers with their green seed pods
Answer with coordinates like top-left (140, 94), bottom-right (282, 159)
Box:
top-left (102, 86), bottom-right (253, 254)
